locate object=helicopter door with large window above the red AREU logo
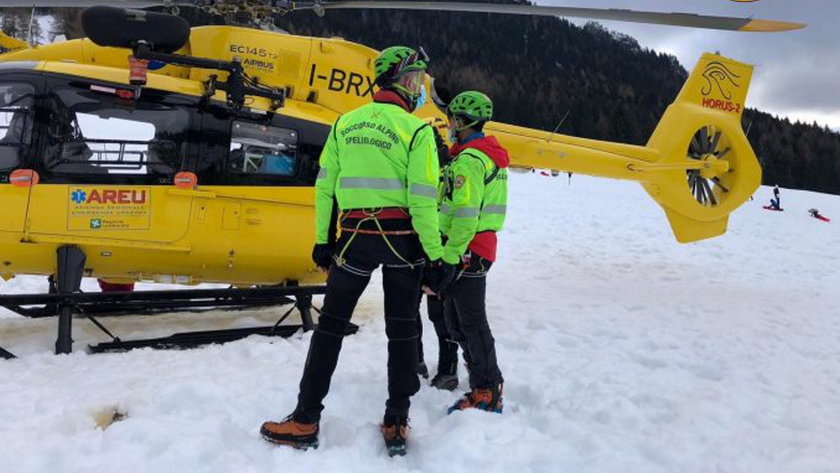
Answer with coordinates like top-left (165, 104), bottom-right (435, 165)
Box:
top-left (22, 82), bottom-right (194, 247)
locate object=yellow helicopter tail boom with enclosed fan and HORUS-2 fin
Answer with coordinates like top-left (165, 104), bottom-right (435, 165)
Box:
top-left (486, 53), bottom-right (761, 243)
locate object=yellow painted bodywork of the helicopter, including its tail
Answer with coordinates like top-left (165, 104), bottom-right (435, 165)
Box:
top-left (0, 26), bottom-right (760, 285)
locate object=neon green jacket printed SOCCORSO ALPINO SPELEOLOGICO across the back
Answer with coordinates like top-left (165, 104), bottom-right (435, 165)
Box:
top-left (315, 98), bottom-right (443, 259)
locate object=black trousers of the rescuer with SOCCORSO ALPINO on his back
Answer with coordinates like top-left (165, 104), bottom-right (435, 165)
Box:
top-left (294, 225), bottom-right (425, 423)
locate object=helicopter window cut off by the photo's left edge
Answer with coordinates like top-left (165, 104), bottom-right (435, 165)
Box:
top-left (0, 82), bottom-right (35, 171)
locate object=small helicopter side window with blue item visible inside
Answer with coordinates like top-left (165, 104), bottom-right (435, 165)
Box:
top-left (227, 121), bottom-right (298, 177)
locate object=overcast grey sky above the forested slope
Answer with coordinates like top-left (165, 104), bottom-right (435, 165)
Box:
top-left (536, 0), bottom-right (840, 130)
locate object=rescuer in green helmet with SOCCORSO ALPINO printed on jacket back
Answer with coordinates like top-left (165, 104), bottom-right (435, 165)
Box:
top-left (261, 46), bottom-right (447, 455)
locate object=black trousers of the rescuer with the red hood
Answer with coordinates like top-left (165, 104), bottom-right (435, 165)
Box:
top-left (444, 254), bottom-right (503, 389)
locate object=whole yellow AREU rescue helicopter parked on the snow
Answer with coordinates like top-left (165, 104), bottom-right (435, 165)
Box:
top-left (0, 0), bottom-right (803, 354)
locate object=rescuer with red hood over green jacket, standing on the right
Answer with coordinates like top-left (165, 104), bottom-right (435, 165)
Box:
top-left (430, 91), bottom-right (510, 413)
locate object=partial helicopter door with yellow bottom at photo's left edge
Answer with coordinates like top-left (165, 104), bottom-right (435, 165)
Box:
top-left (0, 80), bottom-right (36, 234)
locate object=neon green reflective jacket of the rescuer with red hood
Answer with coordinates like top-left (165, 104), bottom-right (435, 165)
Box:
top-left (440, 148), bottom-right (508, 264)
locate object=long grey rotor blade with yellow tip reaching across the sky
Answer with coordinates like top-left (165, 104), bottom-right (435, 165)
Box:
top-left (316, 0), bottom-right (805, 32)
